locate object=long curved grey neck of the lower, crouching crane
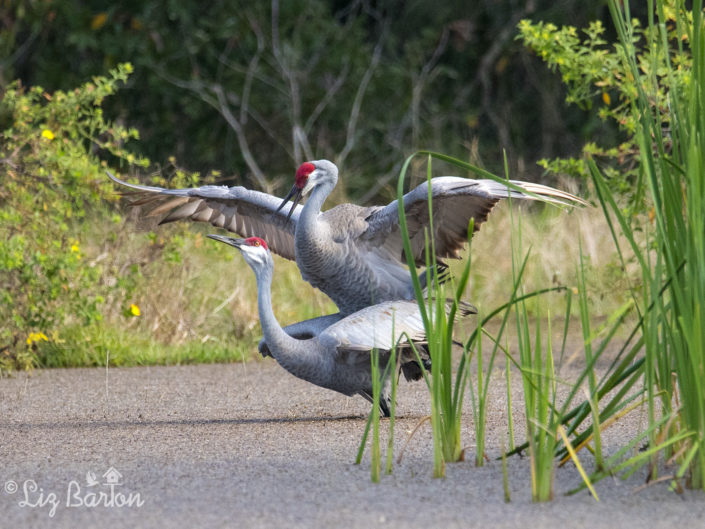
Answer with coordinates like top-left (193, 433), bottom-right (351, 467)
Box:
top-left (257, 267), bottom-right (312, 376)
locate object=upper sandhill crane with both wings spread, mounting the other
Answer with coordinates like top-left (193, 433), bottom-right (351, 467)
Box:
top-left (108, 160), bottom-right (585, 318)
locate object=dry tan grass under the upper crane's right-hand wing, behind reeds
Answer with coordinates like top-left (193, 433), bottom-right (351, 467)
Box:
top-left (456, 201), bottom-right (634, 316)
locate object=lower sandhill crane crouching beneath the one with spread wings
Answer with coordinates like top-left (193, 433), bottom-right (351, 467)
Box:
top-left (208, 235), bottom-right (474, 417)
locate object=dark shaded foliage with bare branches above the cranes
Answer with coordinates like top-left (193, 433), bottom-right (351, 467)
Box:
top-left (0, 0), bottom-right (606, 200)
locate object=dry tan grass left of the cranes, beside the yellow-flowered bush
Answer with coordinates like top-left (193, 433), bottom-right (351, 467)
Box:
top-left (87, 212), bottom-right (335, 345)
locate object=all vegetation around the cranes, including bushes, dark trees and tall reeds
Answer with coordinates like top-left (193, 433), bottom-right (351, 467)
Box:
top-left (0, 0), bottom-right (705, 500)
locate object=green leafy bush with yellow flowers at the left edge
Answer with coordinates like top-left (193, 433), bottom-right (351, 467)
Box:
top-left (0, 64), bottom-right (147, 367)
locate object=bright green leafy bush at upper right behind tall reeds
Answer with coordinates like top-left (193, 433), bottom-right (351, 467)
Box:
top-left (519, 8), bottom-right (692, 210)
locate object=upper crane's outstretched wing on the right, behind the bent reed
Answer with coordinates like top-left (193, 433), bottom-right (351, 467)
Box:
top-left (359, 176), bottom-right (587, 266)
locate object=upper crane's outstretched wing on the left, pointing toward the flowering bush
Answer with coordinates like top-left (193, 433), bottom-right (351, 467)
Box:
top-left (108, 171), bottom-right (302, 260)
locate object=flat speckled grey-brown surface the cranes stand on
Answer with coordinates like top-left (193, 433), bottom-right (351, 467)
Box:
top-left (0, 361), bottom-right (705, 529)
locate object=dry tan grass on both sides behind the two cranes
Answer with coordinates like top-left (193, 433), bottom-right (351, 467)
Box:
top-left (80, 196), bottom-right (626, 360)
